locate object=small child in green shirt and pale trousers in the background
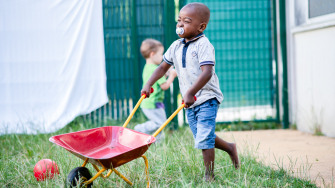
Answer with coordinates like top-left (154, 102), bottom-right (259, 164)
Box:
top-left (134, 39), bottom-right (177, 141)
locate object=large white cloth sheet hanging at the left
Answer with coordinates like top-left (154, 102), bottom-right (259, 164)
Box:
top-left (0, 0), bottom-right (108, 135)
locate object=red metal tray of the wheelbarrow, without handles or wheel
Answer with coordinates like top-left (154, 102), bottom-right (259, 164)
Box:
top-left (49, 126), bottom-right (156, 169)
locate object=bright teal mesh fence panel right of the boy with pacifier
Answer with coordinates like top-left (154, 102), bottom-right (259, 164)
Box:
top-left (184, 0), bottom-right (277, 121)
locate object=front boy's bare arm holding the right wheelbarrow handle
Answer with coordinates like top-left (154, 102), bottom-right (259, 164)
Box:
top-left (183, 65), bottom-right (213, 108)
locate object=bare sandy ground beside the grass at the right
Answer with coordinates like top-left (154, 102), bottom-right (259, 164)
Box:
top-left (217, 130), bottom-right (335, 187)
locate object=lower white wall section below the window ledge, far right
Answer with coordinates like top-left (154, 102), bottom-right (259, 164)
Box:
top-left (293, 26), bottom-right (335, 137)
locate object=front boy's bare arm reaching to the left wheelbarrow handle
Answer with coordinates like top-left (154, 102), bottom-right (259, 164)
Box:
top-left (141, 61), bottom-right (171, 98)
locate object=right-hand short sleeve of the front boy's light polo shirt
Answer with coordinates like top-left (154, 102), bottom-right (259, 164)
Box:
top-left (198, 39), bottom-right (215, 66)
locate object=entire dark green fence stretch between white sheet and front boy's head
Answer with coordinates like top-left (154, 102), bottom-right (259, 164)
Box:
top-left (89, 0), bottom-right (176, 123)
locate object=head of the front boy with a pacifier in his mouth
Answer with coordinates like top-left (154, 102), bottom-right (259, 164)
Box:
top-left (177, 3), bottom-right (210, 39)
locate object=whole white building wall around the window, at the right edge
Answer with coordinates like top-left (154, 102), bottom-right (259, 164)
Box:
top-left (286, 0), bottom-right (335, 137)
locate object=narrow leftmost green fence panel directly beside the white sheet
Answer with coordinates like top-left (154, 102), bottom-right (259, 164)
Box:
top-left (103, 0), bottom-right (137, 118)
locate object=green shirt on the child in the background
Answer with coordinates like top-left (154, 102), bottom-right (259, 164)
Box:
top-left (141, 64), bottom-right (166, 109)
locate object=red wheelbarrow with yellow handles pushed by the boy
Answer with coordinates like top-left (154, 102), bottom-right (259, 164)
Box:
top-left (49, 95), bottom-right (193, 187)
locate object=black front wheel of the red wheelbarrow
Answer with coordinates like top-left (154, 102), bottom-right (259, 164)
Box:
top-left (66, 167), bottom-right (93, 188)
